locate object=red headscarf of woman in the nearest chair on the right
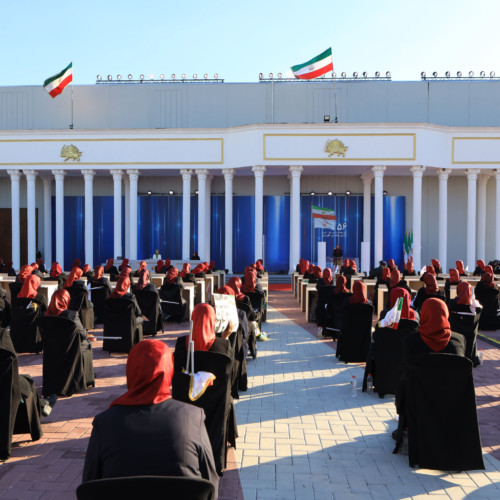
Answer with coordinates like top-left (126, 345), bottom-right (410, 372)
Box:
top-left (418, 298), bottom-right (451, 352)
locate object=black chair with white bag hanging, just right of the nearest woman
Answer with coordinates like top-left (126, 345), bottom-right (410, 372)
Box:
top-left (172, 346), bottom-right (237, 475)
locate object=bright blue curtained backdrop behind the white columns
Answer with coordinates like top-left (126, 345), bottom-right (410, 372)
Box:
top-left (51, 196), bottom-right (405, 273)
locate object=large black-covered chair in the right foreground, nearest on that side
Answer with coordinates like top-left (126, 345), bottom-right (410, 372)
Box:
top-left (394, 353), bottom-right (484, 471)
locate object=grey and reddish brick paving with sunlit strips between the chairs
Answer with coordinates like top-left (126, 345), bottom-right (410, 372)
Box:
top-left (0, 291), bottom-right (500, 500)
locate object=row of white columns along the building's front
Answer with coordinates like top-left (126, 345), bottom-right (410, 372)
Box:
top-left (7, 165), bottom-right (500, 272)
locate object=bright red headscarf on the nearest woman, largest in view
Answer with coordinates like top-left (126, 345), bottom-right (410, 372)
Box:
top-left (110, 340), bottom-right (174, 407)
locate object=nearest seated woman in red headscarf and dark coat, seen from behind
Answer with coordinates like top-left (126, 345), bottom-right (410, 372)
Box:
top-left (83, 340), bottom-right (219, 492)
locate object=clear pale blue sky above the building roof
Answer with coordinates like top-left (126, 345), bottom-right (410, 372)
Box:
top-left (0, 0), bottom-right (500, 86)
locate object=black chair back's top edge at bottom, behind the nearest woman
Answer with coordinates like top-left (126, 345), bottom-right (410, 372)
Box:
top-left (76, 476), bottom-right (216, 500)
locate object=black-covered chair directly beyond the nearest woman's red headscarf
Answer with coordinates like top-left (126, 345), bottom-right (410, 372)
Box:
top-left (102, 298), bottom-right (142, 352)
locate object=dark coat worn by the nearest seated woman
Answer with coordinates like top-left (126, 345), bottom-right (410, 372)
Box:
top-left (82, 399), bottom-right (219, 491)
